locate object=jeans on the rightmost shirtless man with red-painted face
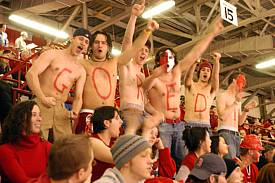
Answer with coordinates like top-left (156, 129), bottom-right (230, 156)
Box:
top-left (219, 130), bottom-right (241, 159)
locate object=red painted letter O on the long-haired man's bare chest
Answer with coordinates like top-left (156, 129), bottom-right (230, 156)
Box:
top-left (92, 67), bottom-right (112, 100)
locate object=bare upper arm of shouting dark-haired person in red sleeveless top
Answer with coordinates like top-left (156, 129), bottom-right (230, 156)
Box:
top-left (90, 137), bottom-right (114, 163)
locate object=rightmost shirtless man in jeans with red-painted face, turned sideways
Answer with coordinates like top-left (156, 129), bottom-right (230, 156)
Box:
top-left (216, 72), bottom-right (257, 159)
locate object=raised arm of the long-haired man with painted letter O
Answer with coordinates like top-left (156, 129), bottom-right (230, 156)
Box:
top-left (116, 20), bottom-right (159, 65)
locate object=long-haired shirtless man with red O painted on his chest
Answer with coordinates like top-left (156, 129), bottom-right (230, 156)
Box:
top-left (76, 20), bottom-right (159, 133)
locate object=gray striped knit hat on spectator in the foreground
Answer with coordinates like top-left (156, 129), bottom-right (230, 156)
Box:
top-left (111, 135), bottom-right (151, 169)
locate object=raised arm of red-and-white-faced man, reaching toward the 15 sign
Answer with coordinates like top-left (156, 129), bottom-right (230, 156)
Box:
top-left (179, 19), bottom-right (223, 72)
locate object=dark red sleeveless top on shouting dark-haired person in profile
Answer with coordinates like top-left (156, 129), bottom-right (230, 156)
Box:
top-left (91, 134), bottom-right (115, 182)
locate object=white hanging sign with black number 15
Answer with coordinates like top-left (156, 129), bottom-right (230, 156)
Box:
top-left (220, 0), bottom-right (238, 26)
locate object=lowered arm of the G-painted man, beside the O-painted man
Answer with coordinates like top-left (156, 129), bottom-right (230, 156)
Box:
top-left (71, 66), bottom-right (86, 119)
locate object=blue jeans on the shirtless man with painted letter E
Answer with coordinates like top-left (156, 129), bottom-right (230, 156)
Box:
top-left (159, 122), bottom-right (187, 168)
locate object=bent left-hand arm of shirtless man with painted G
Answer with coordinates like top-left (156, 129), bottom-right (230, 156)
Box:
top-left (26, 50), bottom-right (56, 107)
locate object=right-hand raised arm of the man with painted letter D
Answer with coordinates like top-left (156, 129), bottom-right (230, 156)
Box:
top-left (211, 52), bottom-right (221, 93)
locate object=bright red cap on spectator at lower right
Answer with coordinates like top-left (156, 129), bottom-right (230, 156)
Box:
top-left (240, 135), bottom-right (264, 150)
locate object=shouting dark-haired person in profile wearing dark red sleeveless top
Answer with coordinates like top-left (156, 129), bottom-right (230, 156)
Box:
top-left (91, 106), bottom-right (122, 182)
